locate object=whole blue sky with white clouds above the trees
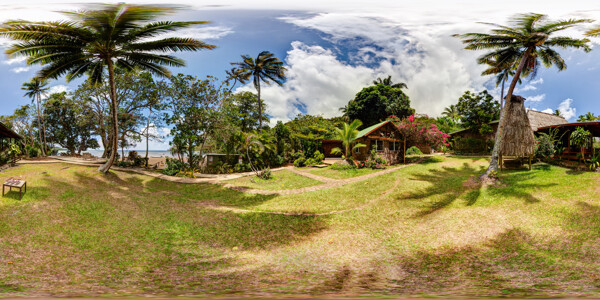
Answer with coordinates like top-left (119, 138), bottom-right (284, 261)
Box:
top-left (0, 0), bottom-right (600, 149)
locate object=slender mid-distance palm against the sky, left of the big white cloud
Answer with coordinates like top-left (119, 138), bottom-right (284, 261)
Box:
top-left (231, 51), bottom-right (287, 130)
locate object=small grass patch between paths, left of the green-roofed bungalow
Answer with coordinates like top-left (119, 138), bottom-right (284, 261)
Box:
top-left (227, 170), bottom-right (322, 190)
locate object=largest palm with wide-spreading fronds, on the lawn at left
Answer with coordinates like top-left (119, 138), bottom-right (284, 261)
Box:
top-left (0, 4), bottom-right (215, 172)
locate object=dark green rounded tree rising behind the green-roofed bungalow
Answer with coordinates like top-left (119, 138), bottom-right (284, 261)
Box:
top-left (342, 84), bottom-right (415, 127)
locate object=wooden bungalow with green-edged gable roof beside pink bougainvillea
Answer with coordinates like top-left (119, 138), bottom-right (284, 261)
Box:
top-left (322, 121), bottom-right (402, 163)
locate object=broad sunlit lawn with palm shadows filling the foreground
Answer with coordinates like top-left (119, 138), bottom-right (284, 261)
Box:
top-left (0, 157), bottom-right (600, 297)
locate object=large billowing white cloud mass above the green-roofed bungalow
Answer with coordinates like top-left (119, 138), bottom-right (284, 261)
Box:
top-left (263, 13), bottom-right (487, 122)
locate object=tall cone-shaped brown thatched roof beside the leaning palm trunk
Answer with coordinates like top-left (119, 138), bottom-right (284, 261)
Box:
top-left (500, 95), bottom-right (535, 157)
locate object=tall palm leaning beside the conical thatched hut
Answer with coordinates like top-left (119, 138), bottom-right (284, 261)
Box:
top-left (455, 14), bottom-right (591, 178)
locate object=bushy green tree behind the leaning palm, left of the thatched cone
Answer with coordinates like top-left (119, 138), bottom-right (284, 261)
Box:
top-left (456, 90), bottom-right (500, 135)
